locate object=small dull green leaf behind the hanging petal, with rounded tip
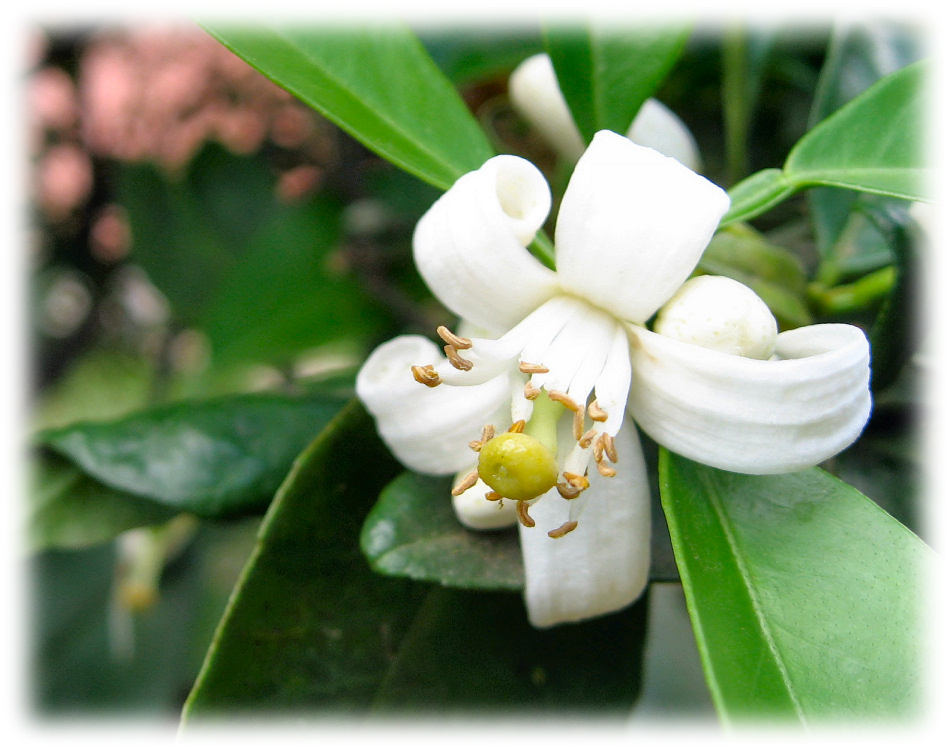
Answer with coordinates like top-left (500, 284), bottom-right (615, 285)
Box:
top-left (360, 472), bottom-right (524, 591)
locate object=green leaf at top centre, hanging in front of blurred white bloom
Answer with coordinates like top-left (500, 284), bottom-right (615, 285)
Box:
top-left (544, 25), bottom-right (689, 143)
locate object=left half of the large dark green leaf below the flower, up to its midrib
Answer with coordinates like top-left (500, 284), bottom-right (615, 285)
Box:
top-left (183, 403), bottom-right (422, 724)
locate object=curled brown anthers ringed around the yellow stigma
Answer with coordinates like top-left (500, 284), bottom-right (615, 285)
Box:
top-left (412, 326), bottom-right (617, 538)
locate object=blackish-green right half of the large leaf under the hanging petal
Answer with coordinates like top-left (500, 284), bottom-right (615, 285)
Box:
top-left (373, 588), bottom-right (648, 720)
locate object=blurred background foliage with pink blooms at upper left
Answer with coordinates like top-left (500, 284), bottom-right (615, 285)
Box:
top-left (25, 19), bottom-right (927, 718)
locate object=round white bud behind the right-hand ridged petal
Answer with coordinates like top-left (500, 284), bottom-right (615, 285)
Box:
top-left (653, 276), bottom-right (778, 359)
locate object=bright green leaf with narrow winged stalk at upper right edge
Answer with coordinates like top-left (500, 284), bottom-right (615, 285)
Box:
top-left (722, 63), bottom-right (931, 225)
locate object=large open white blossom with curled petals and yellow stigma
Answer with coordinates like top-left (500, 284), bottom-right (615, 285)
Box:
top-left (357, 131), bottom-right (870, 627)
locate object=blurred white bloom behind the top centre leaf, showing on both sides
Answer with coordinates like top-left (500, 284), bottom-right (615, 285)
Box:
top-left (508, 54), bottom-right (702, 172)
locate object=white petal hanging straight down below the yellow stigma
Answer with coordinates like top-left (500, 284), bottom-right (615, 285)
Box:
top-left (519, 420), bottom-right (650, 628)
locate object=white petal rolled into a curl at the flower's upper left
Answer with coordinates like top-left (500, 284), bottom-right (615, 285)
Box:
top-left (413, 156), bottom-right (557, 330)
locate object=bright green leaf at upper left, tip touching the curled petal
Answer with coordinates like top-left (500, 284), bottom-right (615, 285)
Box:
top-left (206, 24), bottom-right (494, 188)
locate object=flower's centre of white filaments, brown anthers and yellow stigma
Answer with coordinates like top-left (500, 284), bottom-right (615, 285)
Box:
top-left (412, 296), bottom-right (630, 537)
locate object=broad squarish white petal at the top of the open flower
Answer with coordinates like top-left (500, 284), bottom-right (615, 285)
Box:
top-left (555, 131), bottom-right (729, 323)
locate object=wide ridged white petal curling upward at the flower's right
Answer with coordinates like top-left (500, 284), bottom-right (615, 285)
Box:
top-left (627, 324), bottom-right (871, 474)
